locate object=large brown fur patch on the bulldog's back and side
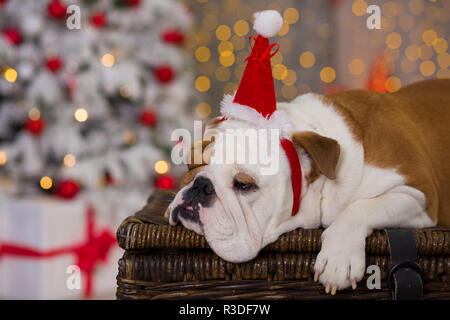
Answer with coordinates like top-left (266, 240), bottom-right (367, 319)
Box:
top-left (325, 79), bottom-right (450, 226)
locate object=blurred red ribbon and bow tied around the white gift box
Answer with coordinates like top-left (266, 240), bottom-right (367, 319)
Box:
top-left (0, 206), bottom-right (117, 298)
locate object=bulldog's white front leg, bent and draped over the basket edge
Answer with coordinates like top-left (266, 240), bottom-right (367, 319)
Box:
top-left (314, 193), bottom-right (432, 294)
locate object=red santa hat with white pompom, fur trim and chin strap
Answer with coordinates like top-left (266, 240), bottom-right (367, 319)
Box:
top-left (220, 10), bottom-right (301, 215)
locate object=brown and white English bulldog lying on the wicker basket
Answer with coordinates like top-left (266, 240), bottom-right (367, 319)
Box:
top-left (167, 80), bottom-right (450, 294)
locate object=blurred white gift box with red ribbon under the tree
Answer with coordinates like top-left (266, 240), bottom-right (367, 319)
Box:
top-left (0, 195), bottom-right (122, 299)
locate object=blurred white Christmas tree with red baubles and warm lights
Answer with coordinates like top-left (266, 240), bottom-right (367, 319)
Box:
top-left (0, 0), bottom-right (194, 210)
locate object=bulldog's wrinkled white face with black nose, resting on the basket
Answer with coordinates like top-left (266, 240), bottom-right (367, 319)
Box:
top-left (169, 120), bottom-right (339, 262)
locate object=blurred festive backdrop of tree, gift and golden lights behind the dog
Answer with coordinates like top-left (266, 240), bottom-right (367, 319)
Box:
top-left (0, 0), bottom-right (450, 299)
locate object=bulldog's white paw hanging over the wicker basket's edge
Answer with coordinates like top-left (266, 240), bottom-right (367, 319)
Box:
top-left (314, 228), bottom-right (366, 295)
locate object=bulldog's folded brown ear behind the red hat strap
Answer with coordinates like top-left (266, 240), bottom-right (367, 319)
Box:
top-left (292, 131), bottom-right (341, 179)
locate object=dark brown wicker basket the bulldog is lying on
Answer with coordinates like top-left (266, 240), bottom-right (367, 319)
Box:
top-left (116, 191), bottom-right (450, 299)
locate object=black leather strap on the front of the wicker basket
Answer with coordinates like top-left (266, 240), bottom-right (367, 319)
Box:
top-left (385, 229), bottom-right (423, 300)
